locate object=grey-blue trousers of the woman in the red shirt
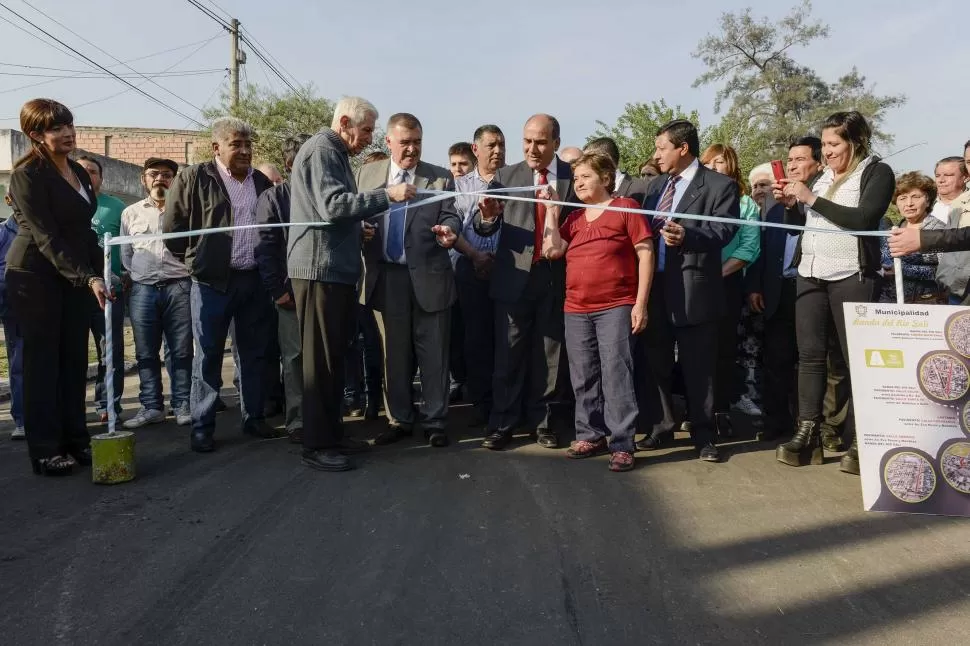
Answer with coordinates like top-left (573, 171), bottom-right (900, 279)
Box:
top-left (566, 305), bottom-right (637, 453)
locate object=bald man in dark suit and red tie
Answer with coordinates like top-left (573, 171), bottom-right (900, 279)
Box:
top-left (476, 114), bottom-right (576, 450)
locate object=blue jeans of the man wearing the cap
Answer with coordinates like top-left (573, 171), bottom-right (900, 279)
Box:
top-left (128, 278), bottom-right (192, 410)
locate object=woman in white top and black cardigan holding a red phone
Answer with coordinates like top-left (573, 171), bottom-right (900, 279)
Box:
top-left (774, 111), bottom-right (896, 472)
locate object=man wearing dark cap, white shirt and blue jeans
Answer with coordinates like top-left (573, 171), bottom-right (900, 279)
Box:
top-left (121, 157), bottom-right (192, 428)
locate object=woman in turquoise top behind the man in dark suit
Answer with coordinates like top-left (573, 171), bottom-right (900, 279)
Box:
top-left (700, 144), bottom-right (761, 437)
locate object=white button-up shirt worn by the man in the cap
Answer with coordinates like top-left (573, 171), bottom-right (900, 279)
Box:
top-left (121, 198), bottom-right (189, 285)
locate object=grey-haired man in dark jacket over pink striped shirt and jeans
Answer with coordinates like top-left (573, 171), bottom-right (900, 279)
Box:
top-left (162, 117), bottom-right (280, 453)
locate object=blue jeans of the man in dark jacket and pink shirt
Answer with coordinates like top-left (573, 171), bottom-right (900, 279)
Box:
top-left (191, 270), bottom-right (271, 433)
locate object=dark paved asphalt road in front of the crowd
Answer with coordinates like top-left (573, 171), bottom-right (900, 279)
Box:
top-left (0, 372), bottom-right (970, 646)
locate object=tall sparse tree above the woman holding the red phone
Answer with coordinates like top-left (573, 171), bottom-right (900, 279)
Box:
top-left (693, 0), bottom-right (906, 161)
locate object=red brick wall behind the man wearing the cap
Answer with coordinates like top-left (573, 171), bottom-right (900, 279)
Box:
top-left (77, 126), bottom-right (208, 166)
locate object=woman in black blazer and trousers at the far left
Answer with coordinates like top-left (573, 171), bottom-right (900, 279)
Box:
top-left (7, 99), bottom-right (108, 475)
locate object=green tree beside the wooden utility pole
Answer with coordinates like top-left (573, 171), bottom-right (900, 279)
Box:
top-left (202, 84), bottom-right (334, 172)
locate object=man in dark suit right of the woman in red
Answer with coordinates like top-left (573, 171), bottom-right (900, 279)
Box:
top-left (637, 119), bottom-right (740, 462)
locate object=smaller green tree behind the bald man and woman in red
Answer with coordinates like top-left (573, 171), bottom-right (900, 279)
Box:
top-left (586, 99), bottom-right (698, 177)
